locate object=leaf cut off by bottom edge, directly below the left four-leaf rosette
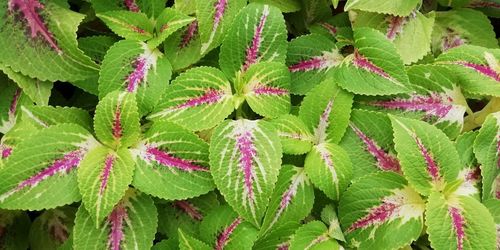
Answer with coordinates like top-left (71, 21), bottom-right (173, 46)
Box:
top-left (73, 189), bottom-right (158, 250)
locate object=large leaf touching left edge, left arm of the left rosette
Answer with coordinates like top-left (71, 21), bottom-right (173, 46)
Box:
top-left (0, 124), bottom-right (98, 210)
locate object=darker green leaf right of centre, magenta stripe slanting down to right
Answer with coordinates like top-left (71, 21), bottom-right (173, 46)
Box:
top-left (340, 109), bottom-right (401, 179)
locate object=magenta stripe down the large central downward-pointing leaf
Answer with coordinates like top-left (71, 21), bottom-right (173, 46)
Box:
top-left (236, 131), bottom-right (257, 201)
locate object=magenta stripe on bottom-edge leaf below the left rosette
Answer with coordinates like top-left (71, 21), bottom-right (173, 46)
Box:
top-left (108, 203), bottom-right (128, 250)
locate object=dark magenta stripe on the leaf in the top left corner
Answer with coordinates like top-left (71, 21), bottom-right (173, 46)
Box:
top-left (8, 0), bottom-right (62, 54)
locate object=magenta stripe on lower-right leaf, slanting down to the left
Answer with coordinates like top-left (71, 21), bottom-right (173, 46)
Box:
top-left (347, 201), bottom-right (398, 232)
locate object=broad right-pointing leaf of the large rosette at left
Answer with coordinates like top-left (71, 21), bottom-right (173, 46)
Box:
top-left (132, 121), bottom-right (214, 200)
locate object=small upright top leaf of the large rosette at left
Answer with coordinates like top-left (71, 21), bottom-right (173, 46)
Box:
top-left (94, 91), bottom-right (141, 148)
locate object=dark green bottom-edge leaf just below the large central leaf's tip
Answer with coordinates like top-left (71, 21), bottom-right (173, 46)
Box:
top-left (200, 205), bottom-right (258, 250)
